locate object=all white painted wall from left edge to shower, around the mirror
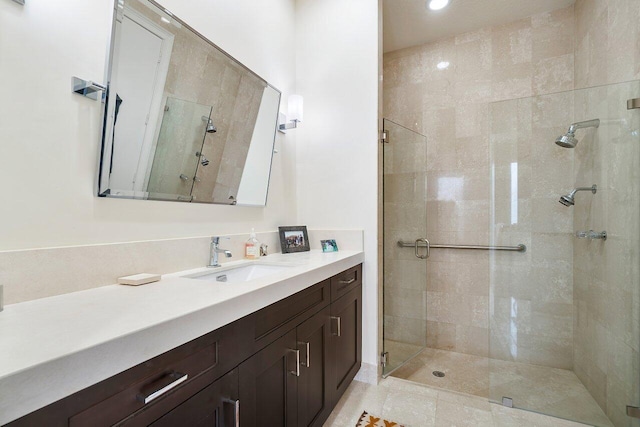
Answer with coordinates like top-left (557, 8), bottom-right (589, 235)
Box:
top-left (0, 0), bottom-right (378, 364)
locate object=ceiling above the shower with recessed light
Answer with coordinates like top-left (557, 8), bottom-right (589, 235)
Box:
top-left (382, 0), bottom-right (575, 52)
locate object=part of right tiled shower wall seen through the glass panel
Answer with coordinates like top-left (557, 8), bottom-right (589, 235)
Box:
top-left (573, 82), bottom-right (640, 426)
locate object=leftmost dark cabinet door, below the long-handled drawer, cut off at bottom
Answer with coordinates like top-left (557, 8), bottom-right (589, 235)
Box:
top-left (150, 369), bottom-right (240, 427)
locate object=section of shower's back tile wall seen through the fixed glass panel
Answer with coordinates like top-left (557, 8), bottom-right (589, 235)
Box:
top-left (490, 91), bottom-right (574, 369)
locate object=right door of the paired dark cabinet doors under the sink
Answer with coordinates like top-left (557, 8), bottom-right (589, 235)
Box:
top-left (296, 307), bottom-right (333, 427)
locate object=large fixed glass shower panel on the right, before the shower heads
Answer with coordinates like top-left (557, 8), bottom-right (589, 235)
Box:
top-left (489, 81), bottom-right (640, 427)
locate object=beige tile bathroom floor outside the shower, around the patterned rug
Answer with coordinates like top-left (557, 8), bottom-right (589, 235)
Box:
top-left (324, 377), bottom-right (584, 427)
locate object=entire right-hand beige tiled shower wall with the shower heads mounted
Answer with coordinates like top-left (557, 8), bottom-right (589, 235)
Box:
top-left (573, 0), bottom-right (640, 426)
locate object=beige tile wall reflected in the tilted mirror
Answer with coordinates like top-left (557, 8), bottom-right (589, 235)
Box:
top-left (128, 2), bottom-right (265, 204)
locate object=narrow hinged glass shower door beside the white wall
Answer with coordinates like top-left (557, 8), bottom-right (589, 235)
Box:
top-left (382, 119), bottom-right (428, 377)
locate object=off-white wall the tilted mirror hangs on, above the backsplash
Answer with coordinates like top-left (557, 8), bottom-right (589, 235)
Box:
top-left (0, 0), bottom-right (296, 250)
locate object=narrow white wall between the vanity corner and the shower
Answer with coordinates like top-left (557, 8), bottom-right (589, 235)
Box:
top-left (295, 0), bottom-right (378, 365)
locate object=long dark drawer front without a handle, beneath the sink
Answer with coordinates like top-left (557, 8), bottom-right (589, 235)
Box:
top-left (239, 279), bottom-right (331, 354)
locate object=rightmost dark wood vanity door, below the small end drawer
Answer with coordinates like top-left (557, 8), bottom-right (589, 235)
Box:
top-left (331, 286), bottom-right (362, 405)
